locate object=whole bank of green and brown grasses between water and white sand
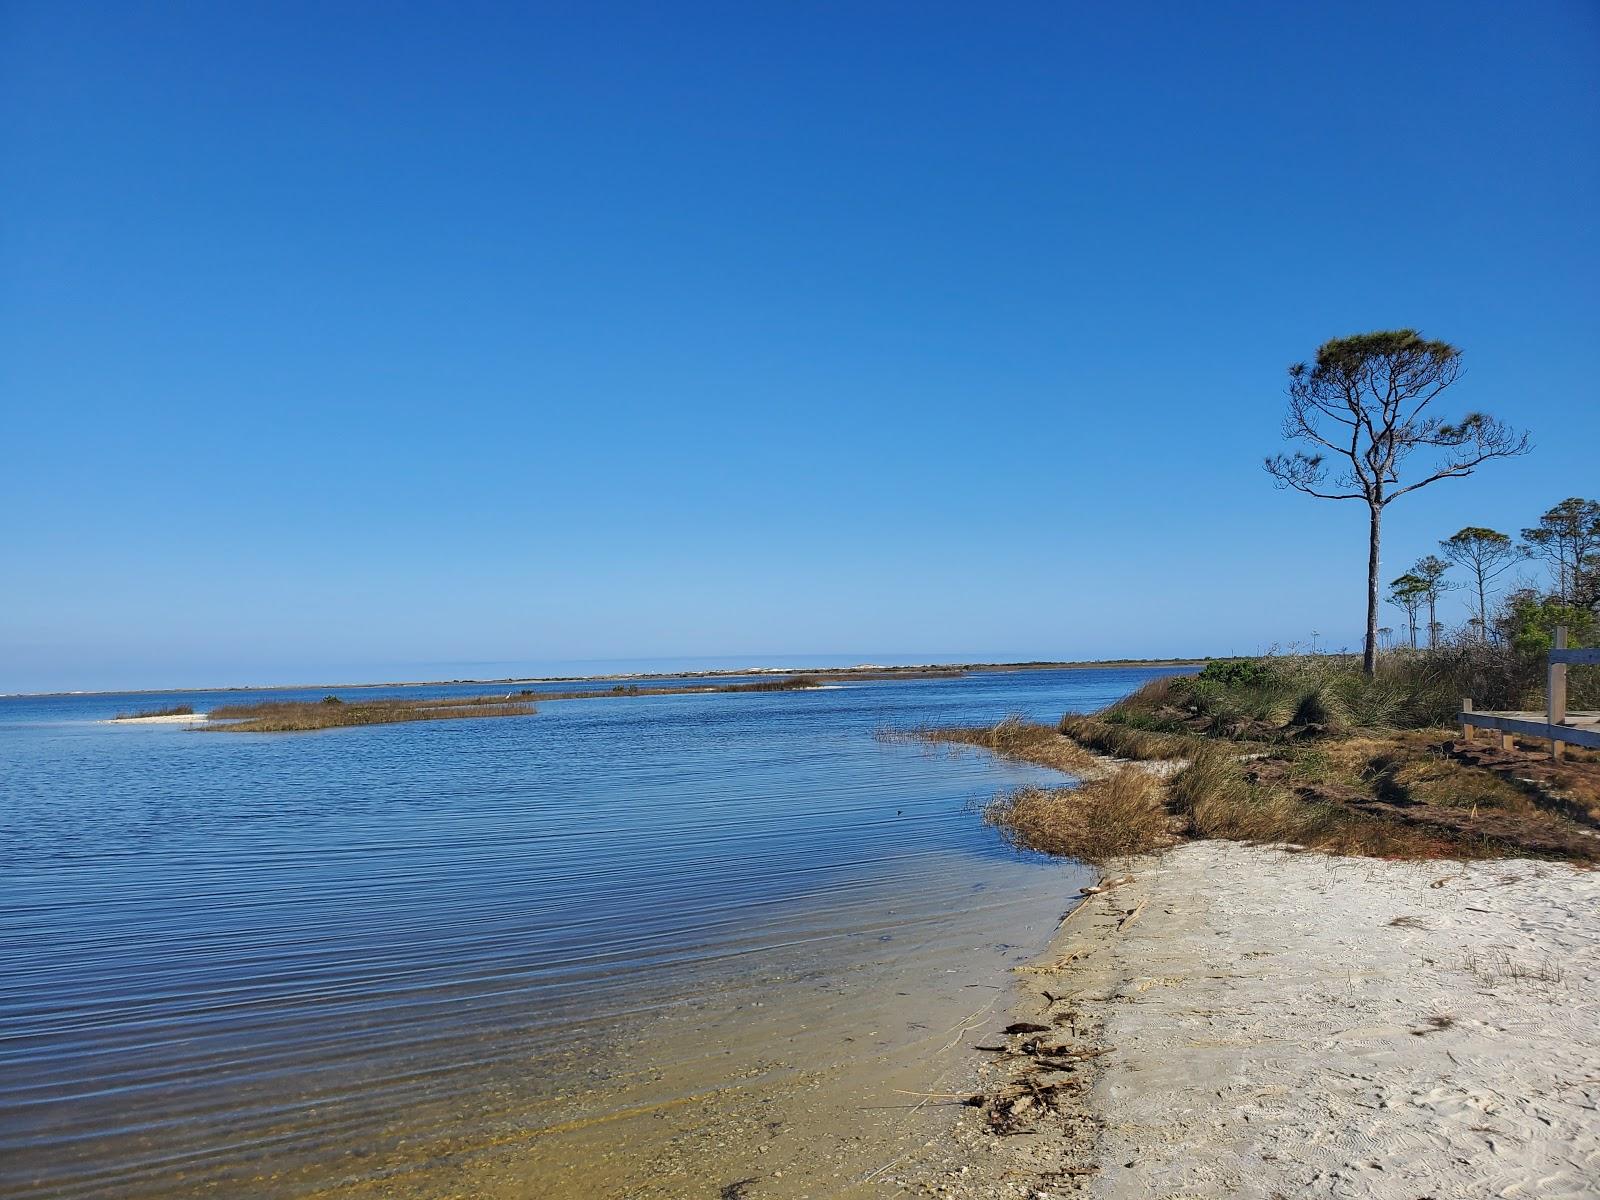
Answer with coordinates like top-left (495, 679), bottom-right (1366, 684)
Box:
top-left (898, 646), bottom-right (1600, 862)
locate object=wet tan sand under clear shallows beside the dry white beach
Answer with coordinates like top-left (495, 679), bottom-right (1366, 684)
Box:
top-left (256, 864), bottom-right (1091, 1200)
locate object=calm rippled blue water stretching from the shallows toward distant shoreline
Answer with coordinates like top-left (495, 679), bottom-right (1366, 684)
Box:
top-left (0, 670), bottom-right (1160, 1198)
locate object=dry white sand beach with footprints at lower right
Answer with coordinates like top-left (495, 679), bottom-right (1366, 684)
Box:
top-left (1088, 842), bottom-right (1600, 1200)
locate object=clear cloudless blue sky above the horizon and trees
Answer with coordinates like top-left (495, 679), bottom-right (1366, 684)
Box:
top-left (0, 0), bottom-right (1600, 691)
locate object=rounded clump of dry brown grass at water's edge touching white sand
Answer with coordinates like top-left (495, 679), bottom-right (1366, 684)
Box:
top-left (984, 771), bottom-right (1173, 862)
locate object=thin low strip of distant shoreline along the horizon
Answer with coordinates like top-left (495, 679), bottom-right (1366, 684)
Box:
top-left (0, 658), bottom-right (1211, 699)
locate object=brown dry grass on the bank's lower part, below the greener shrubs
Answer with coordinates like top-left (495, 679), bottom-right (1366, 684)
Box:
top-left (902, 714), bottom-right (1600, 862)
